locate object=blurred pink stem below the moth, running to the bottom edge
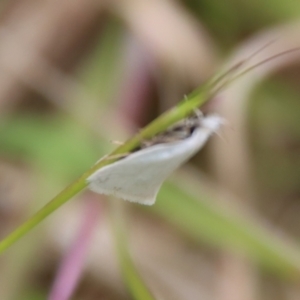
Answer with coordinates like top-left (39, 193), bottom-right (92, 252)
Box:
top-left (48, 196), bottom-right (100, 300)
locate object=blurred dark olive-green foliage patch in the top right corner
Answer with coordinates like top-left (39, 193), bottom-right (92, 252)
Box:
top-left (185, 0), bottom-right (300, 48)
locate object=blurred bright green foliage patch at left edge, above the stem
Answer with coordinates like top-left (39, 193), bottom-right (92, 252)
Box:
top-left (0, 115), bottom-right (101, 180)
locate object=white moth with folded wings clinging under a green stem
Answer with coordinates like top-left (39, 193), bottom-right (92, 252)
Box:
top-left (87, 111), bottom-right (224, 205)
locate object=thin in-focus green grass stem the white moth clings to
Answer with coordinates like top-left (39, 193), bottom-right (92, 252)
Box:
top-left (0, 43), bottom-right (300, 253)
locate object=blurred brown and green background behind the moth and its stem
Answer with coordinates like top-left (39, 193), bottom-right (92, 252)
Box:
top-left (0, 0), bottom-right (300, 300)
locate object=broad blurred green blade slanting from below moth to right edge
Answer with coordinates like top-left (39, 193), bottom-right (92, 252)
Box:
top-left (151, 177), bottom-right (300, 277)
